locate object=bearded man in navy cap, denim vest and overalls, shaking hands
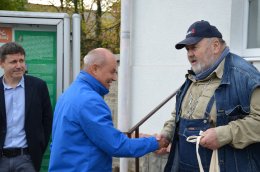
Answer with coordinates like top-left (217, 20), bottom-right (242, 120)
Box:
top-left (160, 21), bottom-right (260, 172)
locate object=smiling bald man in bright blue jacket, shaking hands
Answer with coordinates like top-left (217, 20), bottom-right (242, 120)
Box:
top-left (49, 48), bottom-right (167, 172)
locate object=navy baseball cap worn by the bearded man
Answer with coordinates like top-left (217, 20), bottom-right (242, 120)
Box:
top-left (175, 20), bottom-right (222, 49)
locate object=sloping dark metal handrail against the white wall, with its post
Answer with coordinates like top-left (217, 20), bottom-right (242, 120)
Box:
top-left (126, 89), bottom-right (179, 172)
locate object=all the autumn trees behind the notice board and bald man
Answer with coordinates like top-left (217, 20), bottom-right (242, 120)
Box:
top-left (0, 0), bottom-right (120, 58)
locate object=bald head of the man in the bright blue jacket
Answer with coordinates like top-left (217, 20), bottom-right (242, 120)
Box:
top-left (84, 48), bottom-right (117, 88)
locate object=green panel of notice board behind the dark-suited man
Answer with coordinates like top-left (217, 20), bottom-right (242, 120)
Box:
top-left (14, 30), bottom-right (57, 172)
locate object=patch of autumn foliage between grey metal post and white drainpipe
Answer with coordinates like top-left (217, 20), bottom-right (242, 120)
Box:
top-left (70, 0), bottom-right (120, 55)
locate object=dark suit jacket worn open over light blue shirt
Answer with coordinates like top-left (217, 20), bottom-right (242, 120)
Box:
top-left (0, 75), bottom-right (52, 171)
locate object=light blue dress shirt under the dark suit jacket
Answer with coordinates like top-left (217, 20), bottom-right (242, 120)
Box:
top-left (3, 77), bottom-right (28, 148)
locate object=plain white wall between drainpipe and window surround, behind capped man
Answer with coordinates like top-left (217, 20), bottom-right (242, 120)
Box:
top-left (129, 0), bottom-right (232, 134)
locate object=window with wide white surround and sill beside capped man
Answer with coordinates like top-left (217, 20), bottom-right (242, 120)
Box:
top-left (230, 0), bottom-right (260, 70)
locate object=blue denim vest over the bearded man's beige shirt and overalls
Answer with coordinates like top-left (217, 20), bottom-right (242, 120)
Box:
top-left (165, 53), bottom-right (260, 172)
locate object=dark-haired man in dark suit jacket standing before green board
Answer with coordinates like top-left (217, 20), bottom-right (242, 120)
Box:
top-left (0, 42), bottom-right (52, 172)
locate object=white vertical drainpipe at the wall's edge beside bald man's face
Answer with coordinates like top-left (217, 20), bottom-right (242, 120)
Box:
top-left (118, 0), bottom-right (131, 172)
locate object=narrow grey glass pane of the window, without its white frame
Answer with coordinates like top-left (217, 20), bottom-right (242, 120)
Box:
top-left (247, 0), bottom-right (260, 48)
